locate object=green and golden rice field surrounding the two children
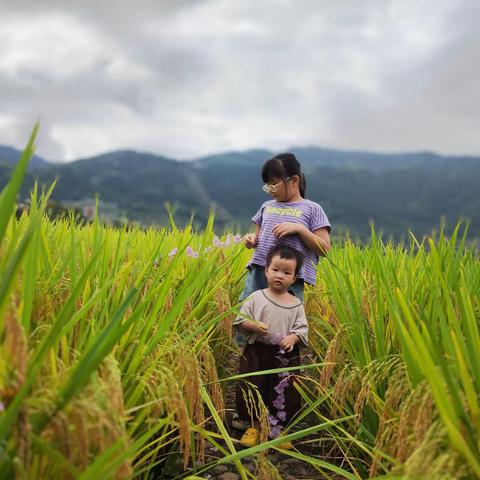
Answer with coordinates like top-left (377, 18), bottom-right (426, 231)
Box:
top-left (0, 129), bottom-right (480, 479)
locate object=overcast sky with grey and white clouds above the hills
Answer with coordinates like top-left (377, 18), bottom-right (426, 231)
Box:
top-left (0, 0), bottom-right (480, 161)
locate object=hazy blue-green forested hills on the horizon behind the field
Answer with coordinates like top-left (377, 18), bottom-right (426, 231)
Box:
top-left (0, 147), bottom-right (480, 238)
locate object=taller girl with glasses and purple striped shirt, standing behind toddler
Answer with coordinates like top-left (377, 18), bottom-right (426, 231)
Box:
top-left (232, 153), bottom-right (330, 430)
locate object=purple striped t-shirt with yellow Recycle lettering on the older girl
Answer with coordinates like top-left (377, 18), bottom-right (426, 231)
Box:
top-left (248, 199), bottom-right (330, 285)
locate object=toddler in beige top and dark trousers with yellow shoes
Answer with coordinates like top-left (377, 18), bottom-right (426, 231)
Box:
top-left (234, 245), bottom-right (308, 449)
